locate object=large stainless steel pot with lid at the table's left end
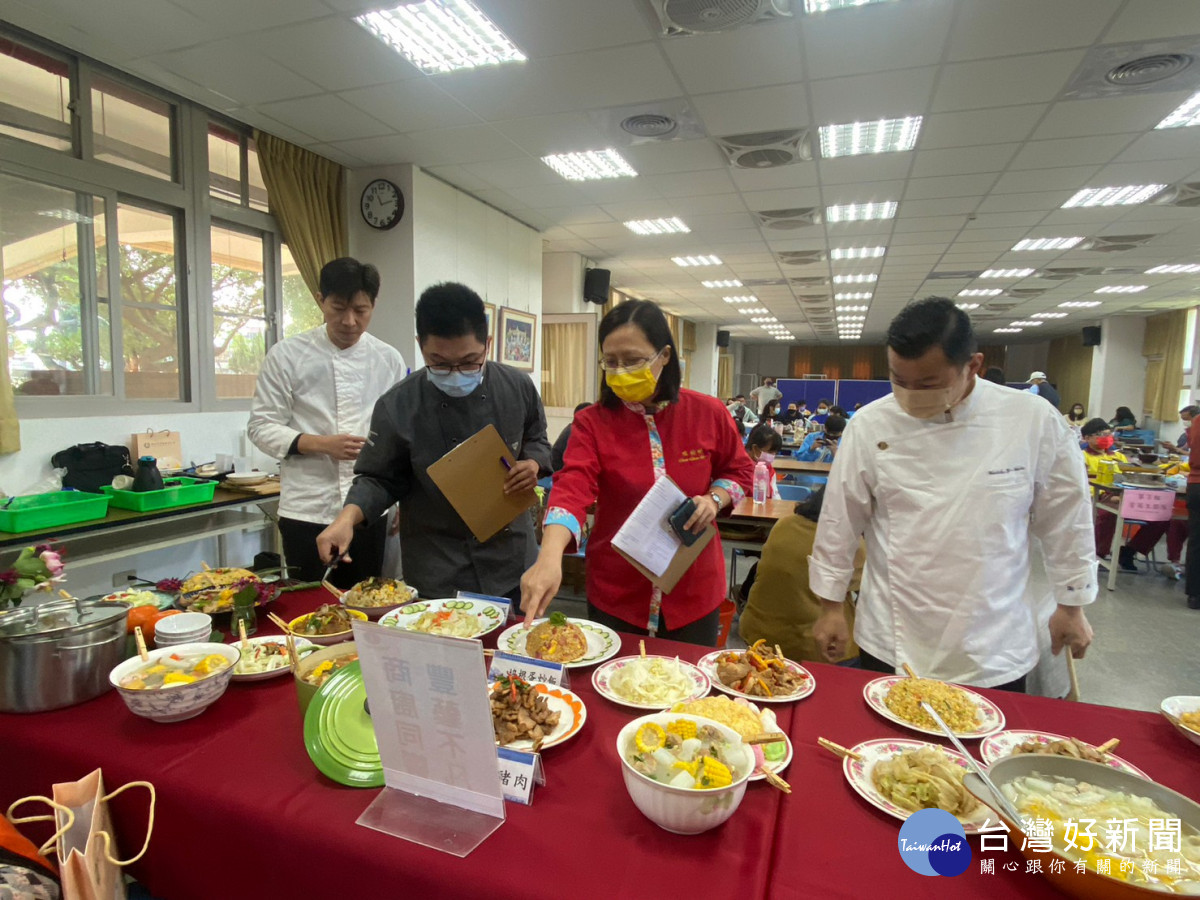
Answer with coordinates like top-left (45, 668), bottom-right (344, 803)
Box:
top-left (0, 600), bottom-right (128, 713)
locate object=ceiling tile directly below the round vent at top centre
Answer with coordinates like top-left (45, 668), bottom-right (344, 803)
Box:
top-left (662, 22), bottom-right (804, 94)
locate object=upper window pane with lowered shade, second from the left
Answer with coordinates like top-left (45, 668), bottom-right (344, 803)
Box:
top-left (91, 76), bottom-right (175, 180)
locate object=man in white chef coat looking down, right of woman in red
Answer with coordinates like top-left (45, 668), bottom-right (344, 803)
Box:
top-left (809, 298), bottom-right (1097, 690)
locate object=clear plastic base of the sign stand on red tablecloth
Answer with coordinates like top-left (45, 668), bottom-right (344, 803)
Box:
top-left (358, 787), bottom-right (504, 858)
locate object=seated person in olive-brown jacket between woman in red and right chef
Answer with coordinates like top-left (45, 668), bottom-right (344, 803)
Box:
top-left (738, 487), bottom-right (866, 662)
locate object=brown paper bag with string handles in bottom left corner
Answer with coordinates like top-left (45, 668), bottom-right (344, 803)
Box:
top-left (53, 769), bottom-right (155, 900)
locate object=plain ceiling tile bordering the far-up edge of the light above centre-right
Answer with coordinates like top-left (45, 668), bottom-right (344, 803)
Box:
top-left (809, 66), bottom-right (937, 125)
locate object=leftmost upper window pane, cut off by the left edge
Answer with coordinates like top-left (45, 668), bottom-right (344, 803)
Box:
top-left (0, 37), bottom-right (72, 151)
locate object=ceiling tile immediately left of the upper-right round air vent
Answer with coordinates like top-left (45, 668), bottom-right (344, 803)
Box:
top-left (932, 50), bottom-right (1084, 113)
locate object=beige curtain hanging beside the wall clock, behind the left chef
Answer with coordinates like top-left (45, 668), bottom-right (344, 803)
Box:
top-left (254, 130), bottom-right (349, 296)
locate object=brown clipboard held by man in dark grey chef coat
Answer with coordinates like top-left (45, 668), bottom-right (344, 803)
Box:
top-left (426, 425), bottom-right (532, 544)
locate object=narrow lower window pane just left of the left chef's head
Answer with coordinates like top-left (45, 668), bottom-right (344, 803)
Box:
top-left (211, 226), bottom-right (268, 400)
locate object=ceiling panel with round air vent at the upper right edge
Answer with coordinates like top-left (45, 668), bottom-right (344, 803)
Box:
top-left (1060, 35), bottom-right (1200, 100)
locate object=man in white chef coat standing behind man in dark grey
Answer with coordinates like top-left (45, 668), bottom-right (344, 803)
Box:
top-left (248, 257), bottom-right (404, 587)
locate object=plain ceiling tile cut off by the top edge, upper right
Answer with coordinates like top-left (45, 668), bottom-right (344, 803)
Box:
top-left (948, 0), bottom-right (1121, 60)
